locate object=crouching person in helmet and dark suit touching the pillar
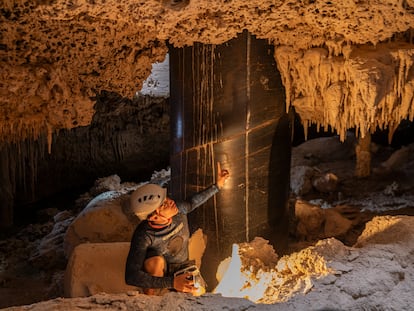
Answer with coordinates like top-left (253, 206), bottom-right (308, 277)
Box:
top-left (125, 163), bottom-right (229, 295)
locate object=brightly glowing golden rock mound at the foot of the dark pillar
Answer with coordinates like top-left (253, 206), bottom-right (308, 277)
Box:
top-left (214, 238), bottom-right (330, 304)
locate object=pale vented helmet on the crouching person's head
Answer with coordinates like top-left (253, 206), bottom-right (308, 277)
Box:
top-left (130, 184), bottom-right (167, 220)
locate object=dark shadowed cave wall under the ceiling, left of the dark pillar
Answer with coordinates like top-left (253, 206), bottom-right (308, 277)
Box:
top-left (0, 92), bottom-right (170, 227)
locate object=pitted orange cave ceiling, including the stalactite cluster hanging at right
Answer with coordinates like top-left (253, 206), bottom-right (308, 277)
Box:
top-left (0, 0), bottom-right (414, 147)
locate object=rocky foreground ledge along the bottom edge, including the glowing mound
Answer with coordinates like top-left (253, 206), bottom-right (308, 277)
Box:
top-left (7, 216), bottom-right (414, 311)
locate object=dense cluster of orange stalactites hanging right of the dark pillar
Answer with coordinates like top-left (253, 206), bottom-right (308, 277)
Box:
top-left (275, 43), bottom-right (414, 141)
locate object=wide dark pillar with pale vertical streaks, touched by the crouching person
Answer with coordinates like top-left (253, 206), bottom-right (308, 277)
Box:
top-left (169, 32), bottom-right (291, 290)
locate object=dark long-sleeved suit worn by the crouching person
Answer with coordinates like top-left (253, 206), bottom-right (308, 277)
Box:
top-left (125, 185), bottom-right (219, 288)
